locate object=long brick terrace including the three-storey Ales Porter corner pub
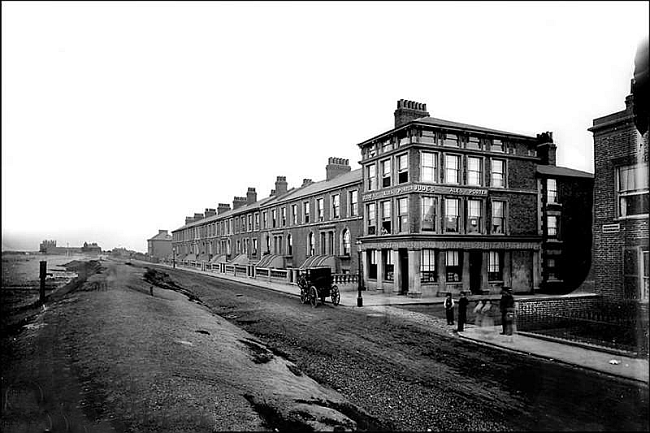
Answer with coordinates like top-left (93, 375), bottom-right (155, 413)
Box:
top-left (172, 100), bottom-right (594, 296)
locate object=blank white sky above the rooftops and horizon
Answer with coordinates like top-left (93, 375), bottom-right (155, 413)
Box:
top-left (2, 1), bottom-right (648, 252)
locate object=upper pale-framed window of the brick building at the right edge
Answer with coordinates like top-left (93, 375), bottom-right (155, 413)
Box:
top-left (616, 164), bottom-right (648, 218)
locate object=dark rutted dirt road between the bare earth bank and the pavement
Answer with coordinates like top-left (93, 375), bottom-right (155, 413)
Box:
top-left (158, 262), bottom-right (648, 431)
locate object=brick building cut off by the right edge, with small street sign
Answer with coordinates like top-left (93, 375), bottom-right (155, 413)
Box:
top-left (589, 95), bottom-right (649, 303)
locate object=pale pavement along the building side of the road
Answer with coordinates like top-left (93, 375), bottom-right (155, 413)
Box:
top-left (154, 264), bottom-right (649, 385)
